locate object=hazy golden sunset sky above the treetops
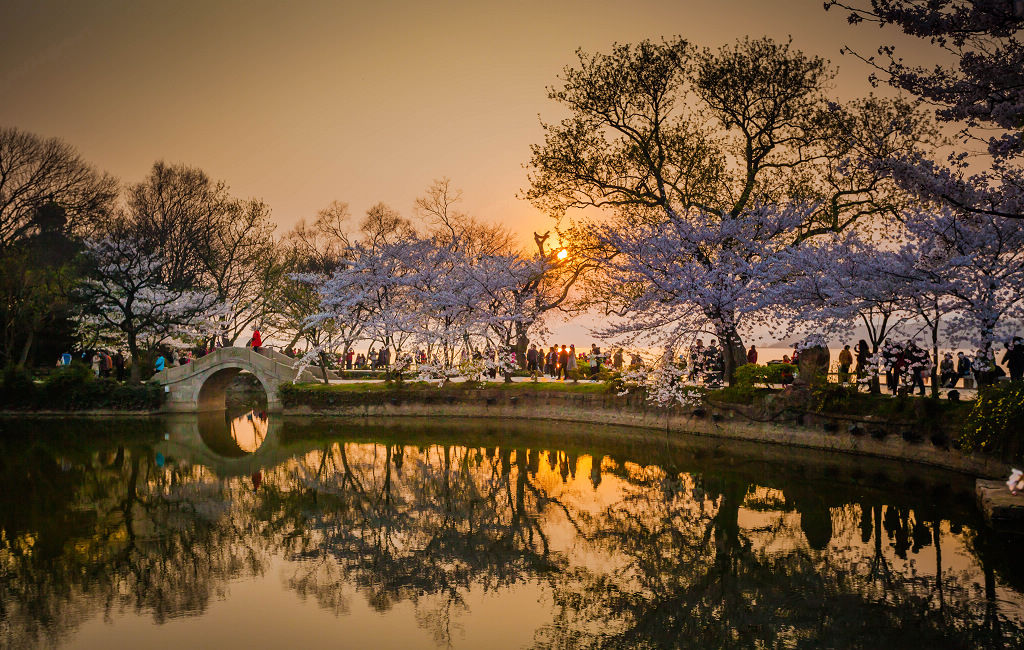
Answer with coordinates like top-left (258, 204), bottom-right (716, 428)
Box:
top-left (0, 0), bottom-right (933, 242)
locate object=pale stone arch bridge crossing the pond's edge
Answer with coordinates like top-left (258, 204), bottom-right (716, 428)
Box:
top-left (153, 348), bottom-right (316, 413)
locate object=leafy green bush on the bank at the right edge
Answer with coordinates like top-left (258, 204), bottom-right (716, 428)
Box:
top-left (959, 382), bottom-right (1024, 462)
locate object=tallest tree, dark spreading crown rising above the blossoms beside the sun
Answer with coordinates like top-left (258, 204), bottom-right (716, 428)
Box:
top-left (526, 39), bottom-right (931, 377)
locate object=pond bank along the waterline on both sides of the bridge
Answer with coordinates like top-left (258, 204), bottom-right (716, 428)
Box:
top-left (0, 382), bottom-right (1010, 478)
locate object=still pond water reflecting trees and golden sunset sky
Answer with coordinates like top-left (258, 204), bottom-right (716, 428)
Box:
top-left (0, 414), bottom-right (1024, 649)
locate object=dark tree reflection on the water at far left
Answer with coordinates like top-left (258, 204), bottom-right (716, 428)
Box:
top-left (0, 429), bottom-right (266, 647)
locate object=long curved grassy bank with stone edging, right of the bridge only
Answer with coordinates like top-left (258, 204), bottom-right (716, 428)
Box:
top-left (282, 384), bottom-right (1010, 478)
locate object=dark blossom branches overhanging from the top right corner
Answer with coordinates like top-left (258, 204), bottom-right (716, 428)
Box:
top-left (824, 0), bottom-right (1024, 219)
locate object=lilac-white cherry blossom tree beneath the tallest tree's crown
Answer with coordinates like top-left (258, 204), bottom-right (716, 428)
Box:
top-left (585, 206), bottom-right (811, 384)
